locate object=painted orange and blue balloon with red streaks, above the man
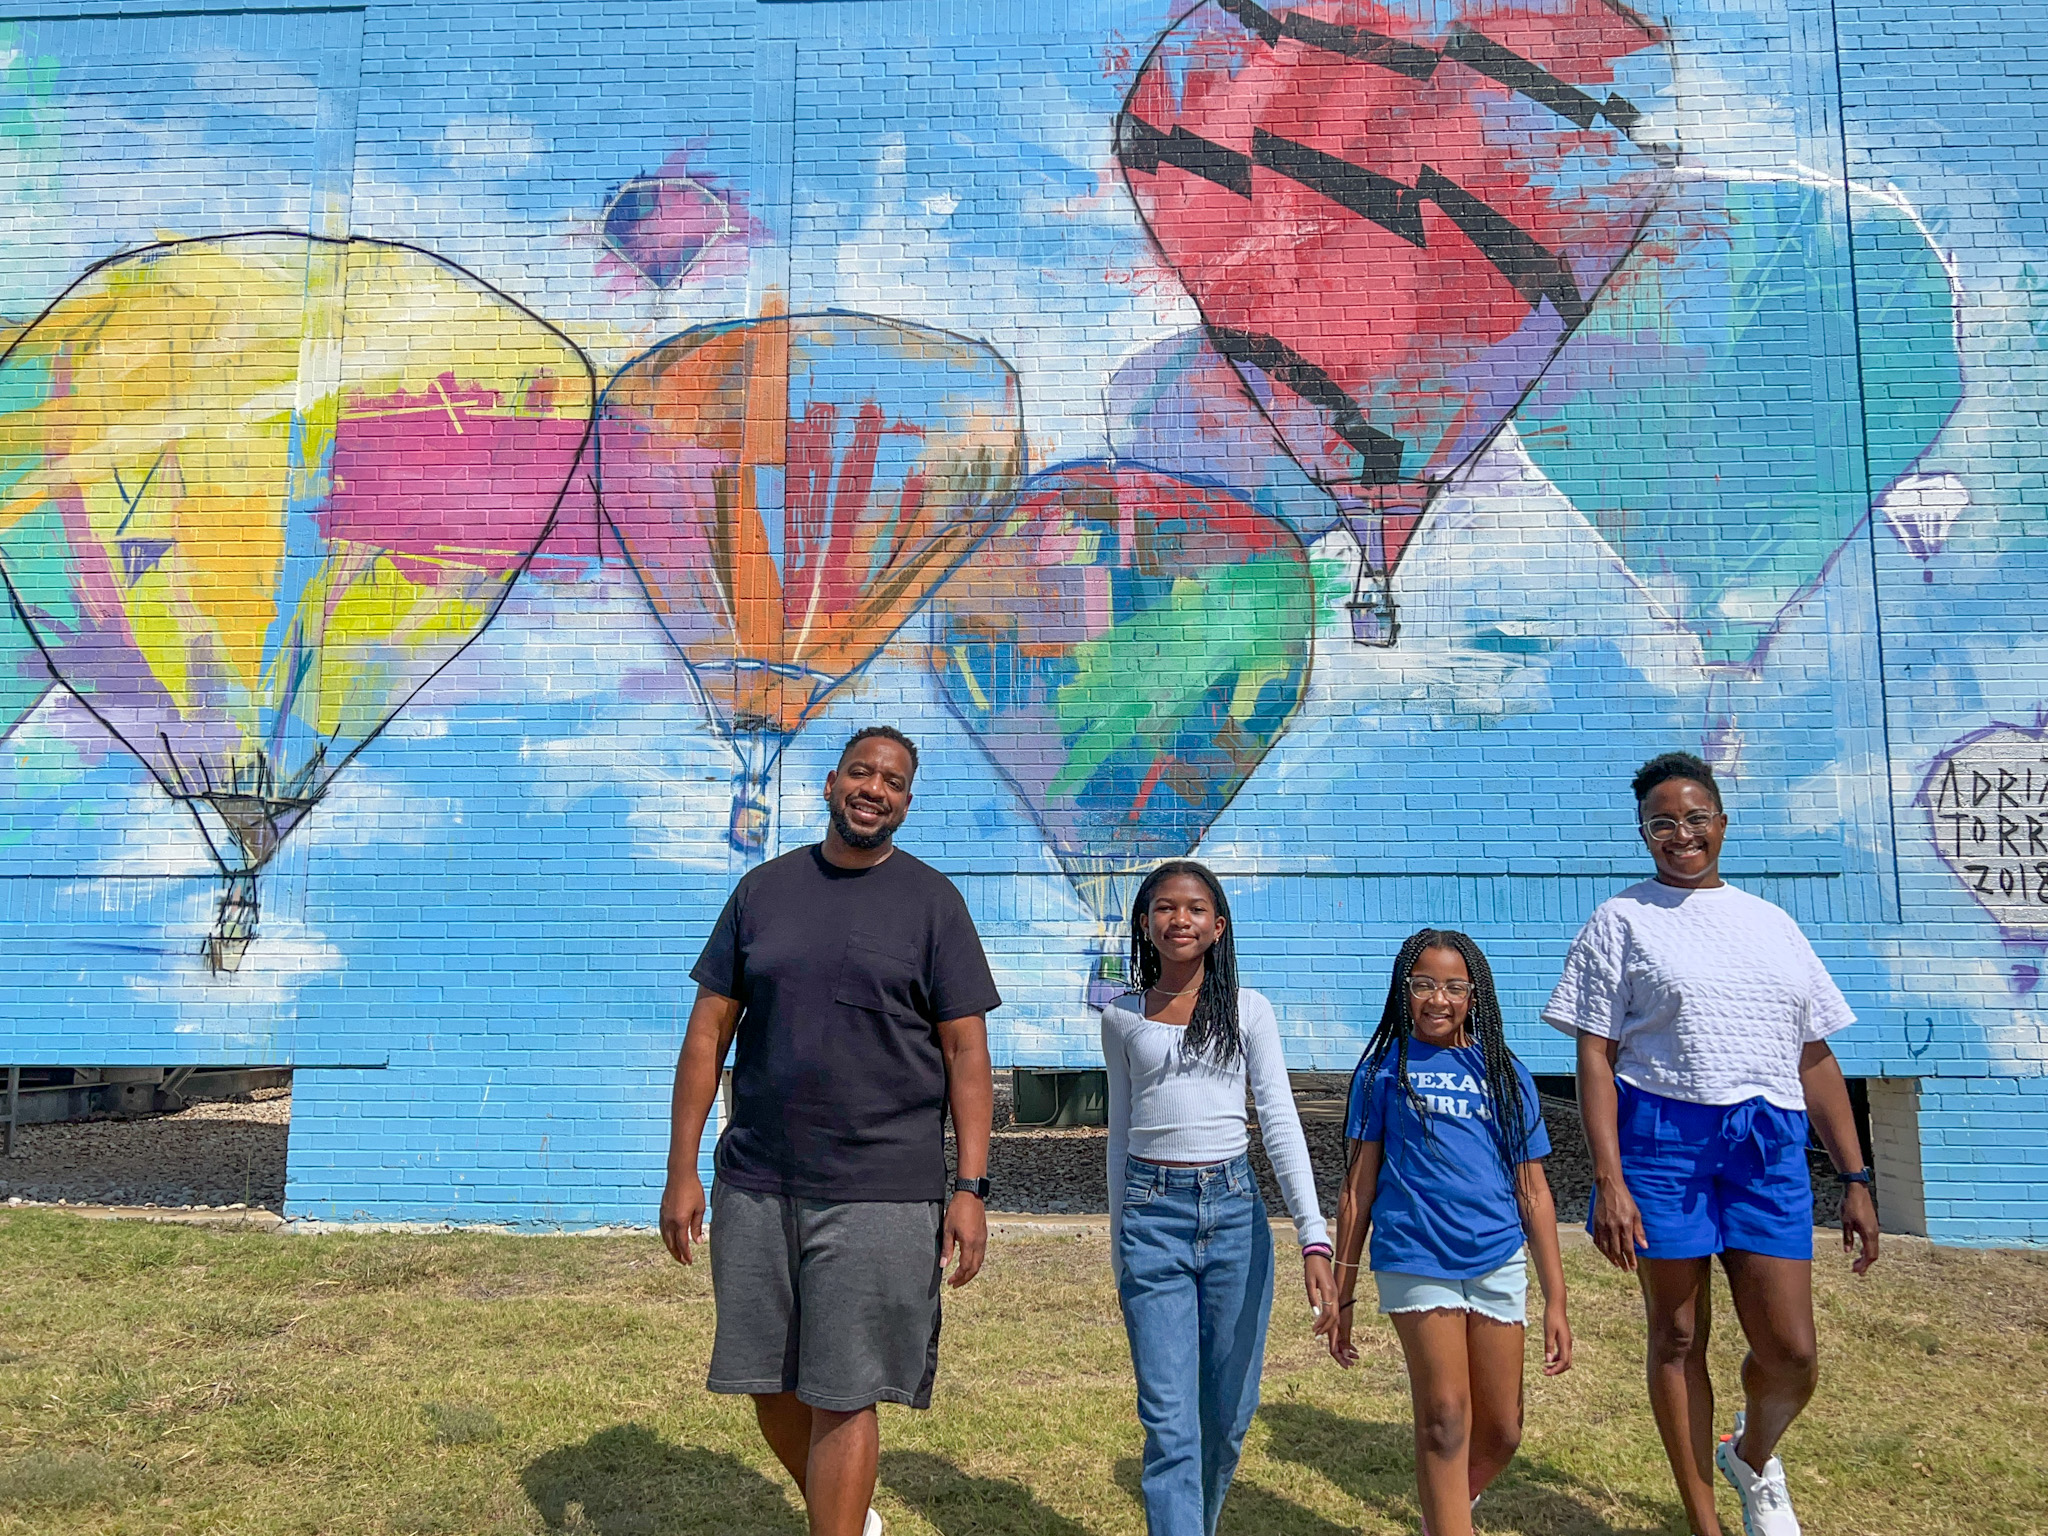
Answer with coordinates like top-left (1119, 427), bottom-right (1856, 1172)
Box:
top-left (598, 313), bottom-right (1024, 860)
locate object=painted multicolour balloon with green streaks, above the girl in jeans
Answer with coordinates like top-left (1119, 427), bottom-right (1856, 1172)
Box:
top-left (930, 463), bottom-right (1315, 1008)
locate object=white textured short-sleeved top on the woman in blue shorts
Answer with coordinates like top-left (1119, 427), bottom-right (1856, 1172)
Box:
top-left (1542, 881), bottom-right (1855, 1110)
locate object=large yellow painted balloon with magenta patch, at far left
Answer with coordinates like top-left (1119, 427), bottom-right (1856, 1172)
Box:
top-left (0, 231), bottom-right (596, 971)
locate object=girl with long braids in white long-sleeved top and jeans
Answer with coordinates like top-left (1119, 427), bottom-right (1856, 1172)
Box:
top-left (1102, 858), bottom-right (1337, 1536)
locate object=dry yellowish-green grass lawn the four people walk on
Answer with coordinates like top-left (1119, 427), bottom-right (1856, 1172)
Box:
top-left (0, 1210), bottom-right (2048, 1536)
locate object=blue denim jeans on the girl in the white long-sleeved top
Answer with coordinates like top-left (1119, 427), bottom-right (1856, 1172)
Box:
top-left (1116, 1157), bottom-right (1274, 1536)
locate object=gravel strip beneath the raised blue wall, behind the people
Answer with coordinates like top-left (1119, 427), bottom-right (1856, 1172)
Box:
top-left (0, 1073), bottom-right (1841, 1227)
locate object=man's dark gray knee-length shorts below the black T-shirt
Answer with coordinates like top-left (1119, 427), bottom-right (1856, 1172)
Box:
top-left (709, 1184), bottom-right (942, 1413)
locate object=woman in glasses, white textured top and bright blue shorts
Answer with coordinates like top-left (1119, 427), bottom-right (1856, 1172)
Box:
top-left (1542, 752), bottom-right (1878, 1536)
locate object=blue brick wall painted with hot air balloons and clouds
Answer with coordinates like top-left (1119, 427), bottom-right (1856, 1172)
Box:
top-left (0, 0), bottom-right (2048, 1241)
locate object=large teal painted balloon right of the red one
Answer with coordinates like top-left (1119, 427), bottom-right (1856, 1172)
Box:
top-left (1516, 176), bottom-right (1962, 668)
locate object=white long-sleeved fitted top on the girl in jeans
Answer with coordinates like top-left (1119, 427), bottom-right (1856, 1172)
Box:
top-left (1102, 987), bottom-right (1329, 1245)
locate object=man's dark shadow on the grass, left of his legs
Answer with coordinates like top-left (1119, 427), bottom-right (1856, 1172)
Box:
top-left (520, 1423), bottom-right (803, 1536)
